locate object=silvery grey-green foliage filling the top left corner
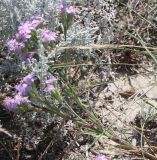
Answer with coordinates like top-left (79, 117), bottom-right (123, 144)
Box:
top-left (0, 0), bottom-right (59, 36)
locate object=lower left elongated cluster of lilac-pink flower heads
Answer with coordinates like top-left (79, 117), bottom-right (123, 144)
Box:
top-left (4, 74), bottom-right (34, 111)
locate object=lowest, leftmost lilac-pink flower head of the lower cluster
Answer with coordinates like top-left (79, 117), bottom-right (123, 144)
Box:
top-left (3, 97), bottom-right (18, 111)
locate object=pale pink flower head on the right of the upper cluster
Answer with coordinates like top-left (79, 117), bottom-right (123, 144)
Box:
top-left (41, 29), bottom-right (57, 42)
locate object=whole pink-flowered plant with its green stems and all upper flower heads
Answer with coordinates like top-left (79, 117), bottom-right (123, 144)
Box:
top-left (4, 1), bottom-right (103, 137)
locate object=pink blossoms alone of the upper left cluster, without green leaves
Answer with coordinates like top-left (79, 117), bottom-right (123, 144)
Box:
top-left (6, 16), bottom-right (57, 60)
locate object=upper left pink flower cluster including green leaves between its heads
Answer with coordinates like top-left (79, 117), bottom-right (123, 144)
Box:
top-left (6, 16), bottom-right (57, 61)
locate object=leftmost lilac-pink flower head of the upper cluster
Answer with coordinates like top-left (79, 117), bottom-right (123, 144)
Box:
top-left (6, 39), bottom-right (25, 53)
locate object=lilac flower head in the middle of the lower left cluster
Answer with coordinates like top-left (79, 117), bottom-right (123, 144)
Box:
top-left (15, 83), bottom-right (31, 96)
